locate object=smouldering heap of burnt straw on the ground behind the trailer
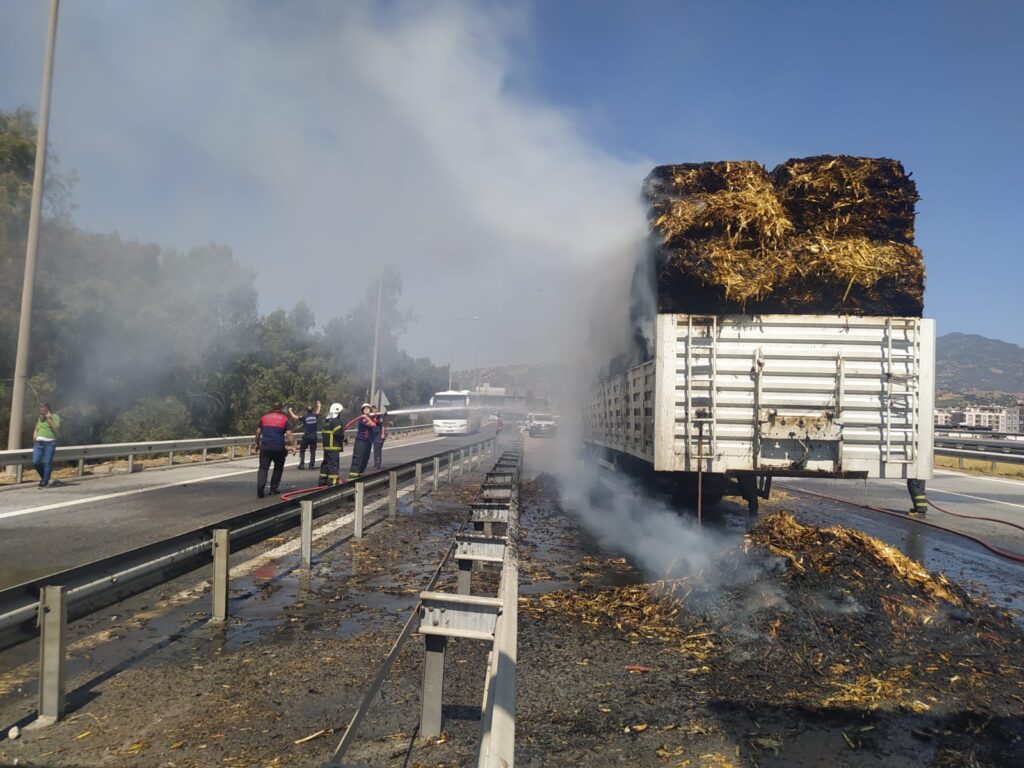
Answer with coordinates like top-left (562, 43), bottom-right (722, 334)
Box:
top-left (519, 483), bottom-right (1024, 766)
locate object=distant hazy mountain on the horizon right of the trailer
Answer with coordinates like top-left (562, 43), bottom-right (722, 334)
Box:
top-left (935, 333), bottom-right (1024, 393)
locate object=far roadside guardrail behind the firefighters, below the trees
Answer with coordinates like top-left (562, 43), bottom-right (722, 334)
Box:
top-left (0, 424), bottom-right (431, 482)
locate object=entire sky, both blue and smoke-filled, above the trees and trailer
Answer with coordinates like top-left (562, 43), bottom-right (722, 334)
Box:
top-left (0, 0), bottom-right (1024, 359)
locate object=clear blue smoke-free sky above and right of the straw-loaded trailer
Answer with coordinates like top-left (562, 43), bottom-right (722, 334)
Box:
top-left (523, 2), bottom-right (1024, 344)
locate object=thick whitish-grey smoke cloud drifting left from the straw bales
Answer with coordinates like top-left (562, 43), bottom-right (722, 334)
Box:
top-left (0, 0), bottom-right (648, 365)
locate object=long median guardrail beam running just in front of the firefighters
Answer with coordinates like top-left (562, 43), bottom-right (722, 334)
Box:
top-left (0, 437), bottom-right (496, 651)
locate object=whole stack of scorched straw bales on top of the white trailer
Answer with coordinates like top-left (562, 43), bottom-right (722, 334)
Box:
top-left (644, 156), bottom-right (925, 316)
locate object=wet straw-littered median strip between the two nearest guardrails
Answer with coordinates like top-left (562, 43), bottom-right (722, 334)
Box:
top-left (0, 460), bottom-right (495, 766)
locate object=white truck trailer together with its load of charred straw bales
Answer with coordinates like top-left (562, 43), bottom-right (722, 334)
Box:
top-left (584, 156), bottom-right (935, 513)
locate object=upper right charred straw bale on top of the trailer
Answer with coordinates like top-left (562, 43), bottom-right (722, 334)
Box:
top-left (771, 155), bottom-right (920, 243)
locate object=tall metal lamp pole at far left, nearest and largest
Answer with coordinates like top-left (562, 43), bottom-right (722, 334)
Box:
top-left (7, 0), bottom-right (59, 451)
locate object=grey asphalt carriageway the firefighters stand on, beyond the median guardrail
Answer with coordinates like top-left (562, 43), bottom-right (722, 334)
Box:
top-left (0, 425), bottom-right (495, 589)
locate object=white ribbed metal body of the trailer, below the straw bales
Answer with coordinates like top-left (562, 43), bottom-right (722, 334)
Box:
top-left (587, 314), bottom-right (935, 479)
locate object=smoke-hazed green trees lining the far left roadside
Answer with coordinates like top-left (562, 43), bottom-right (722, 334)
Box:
top-left (0, 111), bottom-right (446, 444)
